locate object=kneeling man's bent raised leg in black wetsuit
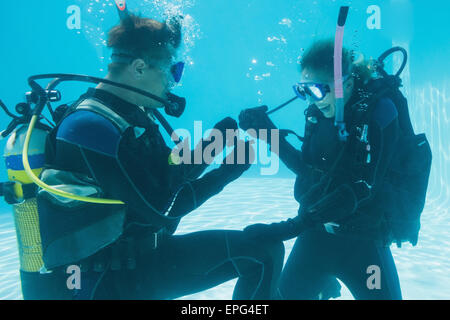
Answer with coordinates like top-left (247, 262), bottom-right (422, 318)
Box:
top-left (110, 231), bottom-right (284, 299)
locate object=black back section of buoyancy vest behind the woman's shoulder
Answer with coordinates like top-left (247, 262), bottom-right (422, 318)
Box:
top-left (358, 75), bottom-right (432, 247)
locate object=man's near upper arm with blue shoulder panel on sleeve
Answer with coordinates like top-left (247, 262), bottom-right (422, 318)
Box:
top-left (55, 111), bottom-right (183, 227)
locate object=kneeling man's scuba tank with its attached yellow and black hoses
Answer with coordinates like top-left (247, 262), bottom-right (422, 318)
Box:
top-left (0, 74), bottom-right (184, 272)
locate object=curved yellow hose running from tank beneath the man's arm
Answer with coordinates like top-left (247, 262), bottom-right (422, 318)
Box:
top-left (22, 115), bottom-right (125, 204)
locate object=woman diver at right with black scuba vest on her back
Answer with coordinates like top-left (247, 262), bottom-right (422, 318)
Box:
top-left (239, 36), bottom-right (431, 300)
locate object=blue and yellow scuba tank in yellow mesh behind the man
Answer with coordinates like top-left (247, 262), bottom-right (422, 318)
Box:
top-left (0, 101), bottom-right (50, 272)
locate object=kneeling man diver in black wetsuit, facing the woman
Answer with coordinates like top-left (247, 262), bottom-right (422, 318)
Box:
top-left (2, 9), bottom-right (284, 300)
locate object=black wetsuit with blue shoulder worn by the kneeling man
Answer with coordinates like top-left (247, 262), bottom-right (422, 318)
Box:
top-left (28, 89), bottom-right (284, 299)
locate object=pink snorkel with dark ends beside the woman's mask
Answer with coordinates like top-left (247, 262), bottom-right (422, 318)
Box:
top-left (334, 7), bottom-right (349, 141)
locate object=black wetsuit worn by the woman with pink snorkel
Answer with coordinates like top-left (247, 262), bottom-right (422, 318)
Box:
top-left (279, 98), bottom-right (401, 299)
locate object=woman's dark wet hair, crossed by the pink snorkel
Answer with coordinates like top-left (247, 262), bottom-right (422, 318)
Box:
top-left (300, 39), bottom-right (374, 88)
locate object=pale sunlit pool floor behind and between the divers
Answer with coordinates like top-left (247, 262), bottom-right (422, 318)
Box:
top-left (0, 178), bottom-right (450, 300)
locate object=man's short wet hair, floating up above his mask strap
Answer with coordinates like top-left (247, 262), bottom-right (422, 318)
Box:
top-left (107, 14), bottom-right (181, 72)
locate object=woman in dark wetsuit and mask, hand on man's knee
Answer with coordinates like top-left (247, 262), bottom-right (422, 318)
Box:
top-left (239, 40), bottom-right (401, 299)
